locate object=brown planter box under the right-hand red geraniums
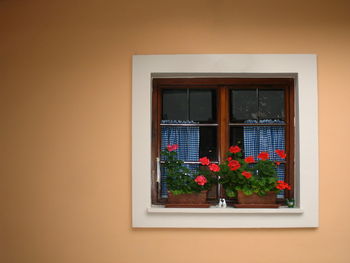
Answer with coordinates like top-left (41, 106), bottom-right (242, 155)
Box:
top-left (234, 191), bottom-right (280, 208)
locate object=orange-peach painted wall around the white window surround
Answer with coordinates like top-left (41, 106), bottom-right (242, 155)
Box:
top-left (0, 0), bottom-right (350, 263)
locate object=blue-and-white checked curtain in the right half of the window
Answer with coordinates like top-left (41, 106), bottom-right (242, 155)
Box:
top-left (243, 119), bottom-right (285, 198)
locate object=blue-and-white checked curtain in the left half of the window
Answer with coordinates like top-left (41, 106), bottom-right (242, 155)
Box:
top-left (161, 120), bottom-right (200, 198)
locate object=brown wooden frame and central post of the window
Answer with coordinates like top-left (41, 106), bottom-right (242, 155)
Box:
top-left (151, 78), bottom-right (295, 204)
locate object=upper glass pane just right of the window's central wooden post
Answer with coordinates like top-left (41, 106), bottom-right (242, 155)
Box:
top-left (230, 89), bottom-right (258, 123)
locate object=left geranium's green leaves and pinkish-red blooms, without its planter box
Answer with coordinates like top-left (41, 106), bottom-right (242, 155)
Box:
top-left (161, 144), bottom-right (213, 195)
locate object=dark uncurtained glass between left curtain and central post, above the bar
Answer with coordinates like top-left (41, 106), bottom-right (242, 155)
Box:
top-left (199, 127), bottom-right (218, 161)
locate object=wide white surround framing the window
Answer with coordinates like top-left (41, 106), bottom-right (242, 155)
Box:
top-left (132, 54), bottom-right (319, 228)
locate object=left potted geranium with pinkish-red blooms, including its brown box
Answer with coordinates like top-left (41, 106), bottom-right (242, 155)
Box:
top-left (161, 144), bottom-right (215, 207)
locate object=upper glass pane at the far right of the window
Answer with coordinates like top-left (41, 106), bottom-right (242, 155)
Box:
top-left (259, 89), bottom-right (284, 120)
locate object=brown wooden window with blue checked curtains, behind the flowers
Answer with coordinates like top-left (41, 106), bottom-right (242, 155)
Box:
top-left (152, 78), bottom-right (294, 204)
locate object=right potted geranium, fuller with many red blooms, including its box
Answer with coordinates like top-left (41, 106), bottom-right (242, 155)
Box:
top-left (200, 146), bottom-right (291, 208)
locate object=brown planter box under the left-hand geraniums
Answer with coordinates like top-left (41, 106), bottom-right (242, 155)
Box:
top-left (165, 191), bottom-right (210, 207)
